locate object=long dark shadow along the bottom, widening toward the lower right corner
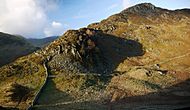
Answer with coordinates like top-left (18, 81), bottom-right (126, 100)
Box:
top-left (35, 80), bottom-right (190, 110)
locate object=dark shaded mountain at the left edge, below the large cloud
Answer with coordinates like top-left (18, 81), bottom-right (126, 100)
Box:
top-left (0, 32), bottom-right (37, 66)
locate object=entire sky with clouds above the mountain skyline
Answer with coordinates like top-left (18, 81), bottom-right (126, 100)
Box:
top-left (0, 0), bottom-right (190, 38)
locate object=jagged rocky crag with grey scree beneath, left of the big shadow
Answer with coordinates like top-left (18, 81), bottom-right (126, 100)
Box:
top-left (47, 28), bottom-right (107, 72)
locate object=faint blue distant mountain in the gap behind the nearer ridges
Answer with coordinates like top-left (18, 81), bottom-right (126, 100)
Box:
top-left (27, 36), bottom-right (58, 47)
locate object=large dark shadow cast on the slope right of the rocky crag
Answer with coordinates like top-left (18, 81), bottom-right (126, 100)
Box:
top-left (93, 32), bottom-right (144, 73)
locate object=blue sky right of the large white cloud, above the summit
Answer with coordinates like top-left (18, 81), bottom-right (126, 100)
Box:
top-left (50, 0), bottom-right (190, 32)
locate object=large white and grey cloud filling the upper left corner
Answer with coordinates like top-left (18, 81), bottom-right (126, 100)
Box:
top-left (0, 0), bottom-right (60, 37)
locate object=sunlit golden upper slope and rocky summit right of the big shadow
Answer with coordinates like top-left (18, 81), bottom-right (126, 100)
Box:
top-left (89, 3), bottom-right (190, 70)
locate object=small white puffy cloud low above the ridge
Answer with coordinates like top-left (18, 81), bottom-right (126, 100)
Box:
top-left (44, 21), bottom-right (69, 37)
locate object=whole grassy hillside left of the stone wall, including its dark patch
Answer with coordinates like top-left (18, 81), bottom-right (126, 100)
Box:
top-left (0, 54), bottom-right (46, 109)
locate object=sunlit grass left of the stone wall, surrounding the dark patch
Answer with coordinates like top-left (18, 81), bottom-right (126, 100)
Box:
top-left (0, 55), bottom-right (45, 109)
